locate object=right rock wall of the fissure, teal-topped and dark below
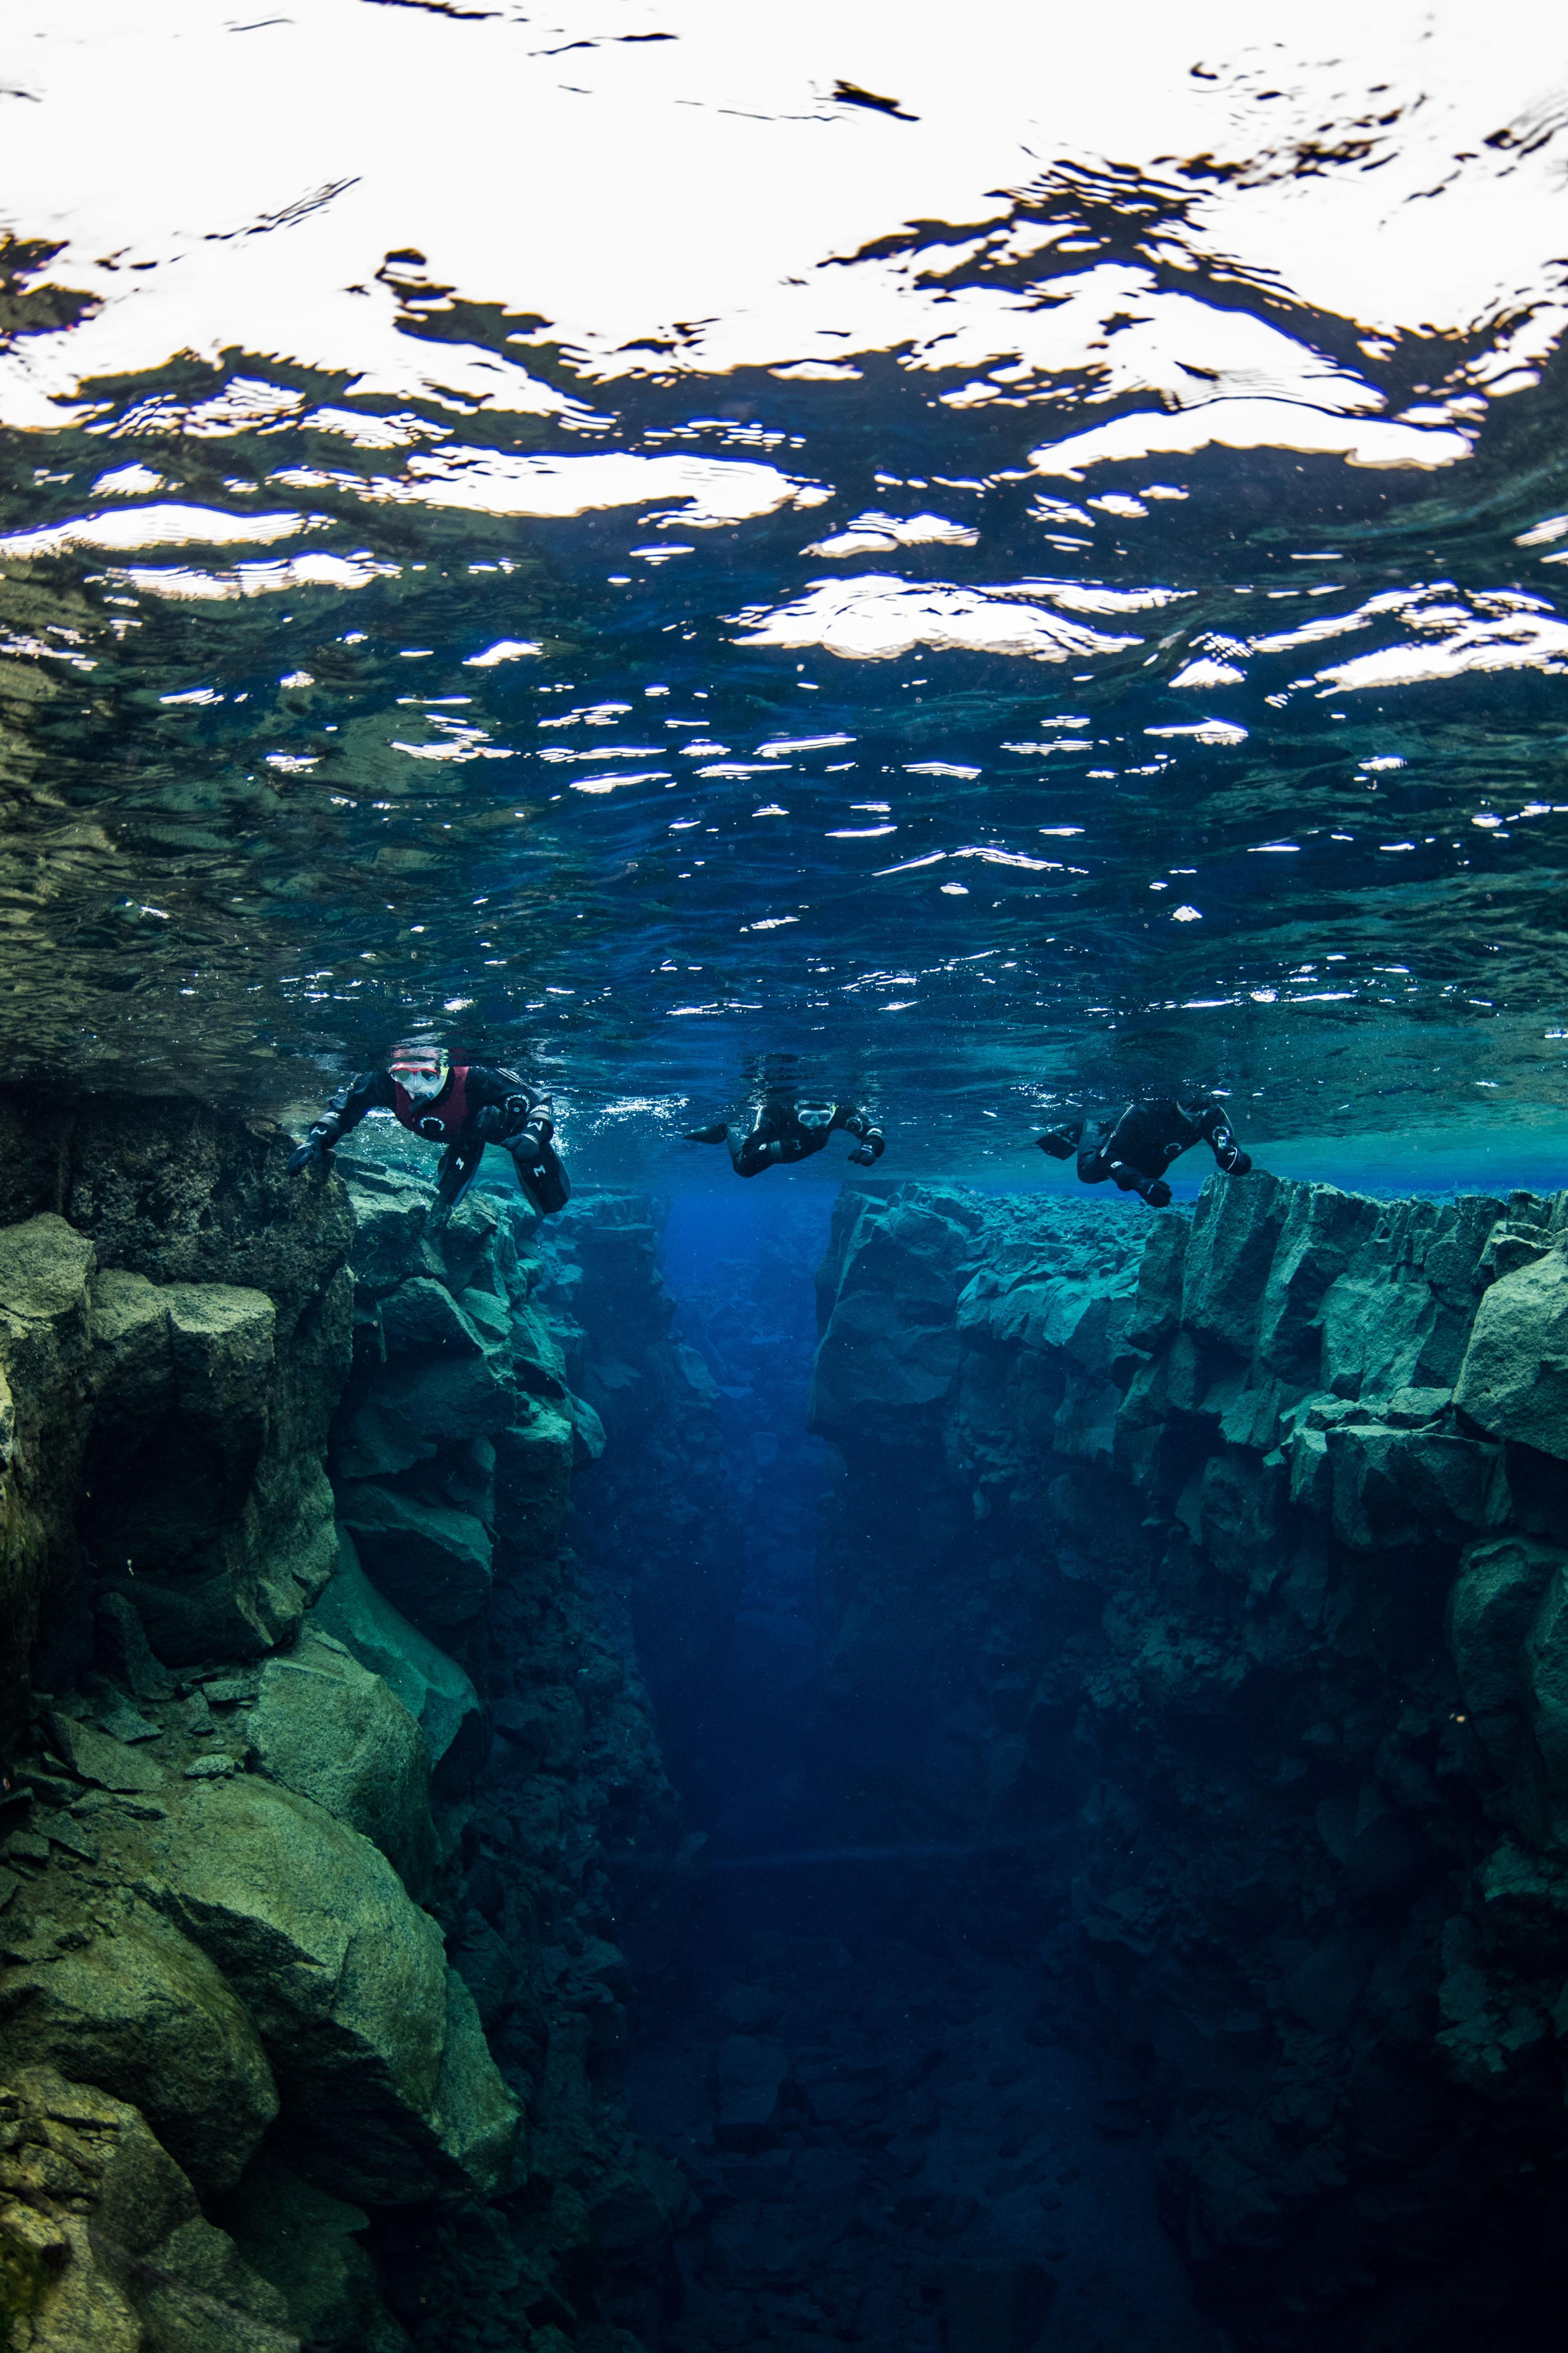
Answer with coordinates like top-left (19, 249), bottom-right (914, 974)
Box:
top-left (813, 1174), bottom-right (1568, 2353)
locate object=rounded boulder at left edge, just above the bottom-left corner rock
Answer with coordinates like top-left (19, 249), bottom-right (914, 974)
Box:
top-left (0, 1904), bottom-right (277, 2190)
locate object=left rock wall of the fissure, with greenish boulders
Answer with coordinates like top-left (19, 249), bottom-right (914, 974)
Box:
top-left (0, 1101), bottom-right (684, 2353)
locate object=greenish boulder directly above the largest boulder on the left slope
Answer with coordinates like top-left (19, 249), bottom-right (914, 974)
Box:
top-left (247, 1638), bottom-right (435, 1887)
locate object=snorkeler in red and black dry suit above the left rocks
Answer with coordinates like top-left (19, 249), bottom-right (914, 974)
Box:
top-left (289, 1045), bottom-right (571, 1219)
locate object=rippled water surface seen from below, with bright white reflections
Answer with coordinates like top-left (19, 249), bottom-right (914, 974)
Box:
top-left (0, 0), bottom-right (1568, 1174)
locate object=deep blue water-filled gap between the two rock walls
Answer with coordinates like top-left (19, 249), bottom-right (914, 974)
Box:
top-left (588, 1191), bottom-right (1220, 2353)
